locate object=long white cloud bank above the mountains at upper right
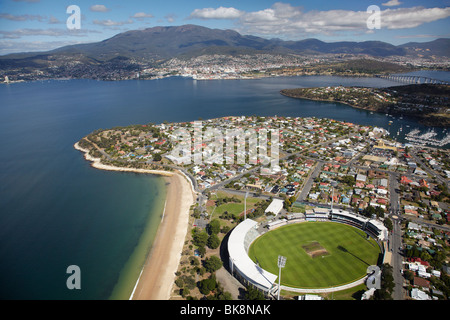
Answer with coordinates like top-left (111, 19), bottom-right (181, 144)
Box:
top-left (190, 0), bottom-right (450, 37)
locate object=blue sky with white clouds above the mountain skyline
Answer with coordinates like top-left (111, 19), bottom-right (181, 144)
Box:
top-left (0, 0), bottom-right (450, 55)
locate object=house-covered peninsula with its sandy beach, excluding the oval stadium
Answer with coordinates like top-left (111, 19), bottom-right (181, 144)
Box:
top-left (75, 116), bottom-right (450, 300)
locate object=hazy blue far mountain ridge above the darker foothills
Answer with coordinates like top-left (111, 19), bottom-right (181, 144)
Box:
top-left (0, 25), bottom-right (450, 61)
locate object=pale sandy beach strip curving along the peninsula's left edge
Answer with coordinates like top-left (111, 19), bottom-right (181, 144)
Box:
top-left (74, 142), bottom-right (195, 300)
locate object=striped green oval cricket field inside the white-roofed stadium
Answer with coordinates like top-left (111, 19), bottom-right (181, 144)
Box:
top-left (249, 222), bottom-right (380, 288)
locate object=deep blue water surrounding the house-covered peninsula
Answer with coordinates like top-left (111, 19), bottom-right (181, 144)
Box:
top-left (0, 72), bottom-right (442, 299)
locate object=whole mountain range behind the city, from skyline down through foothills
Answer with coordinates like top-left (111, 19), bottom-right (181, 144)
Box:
top-left (0, 25), bottom-right (450, 79)
